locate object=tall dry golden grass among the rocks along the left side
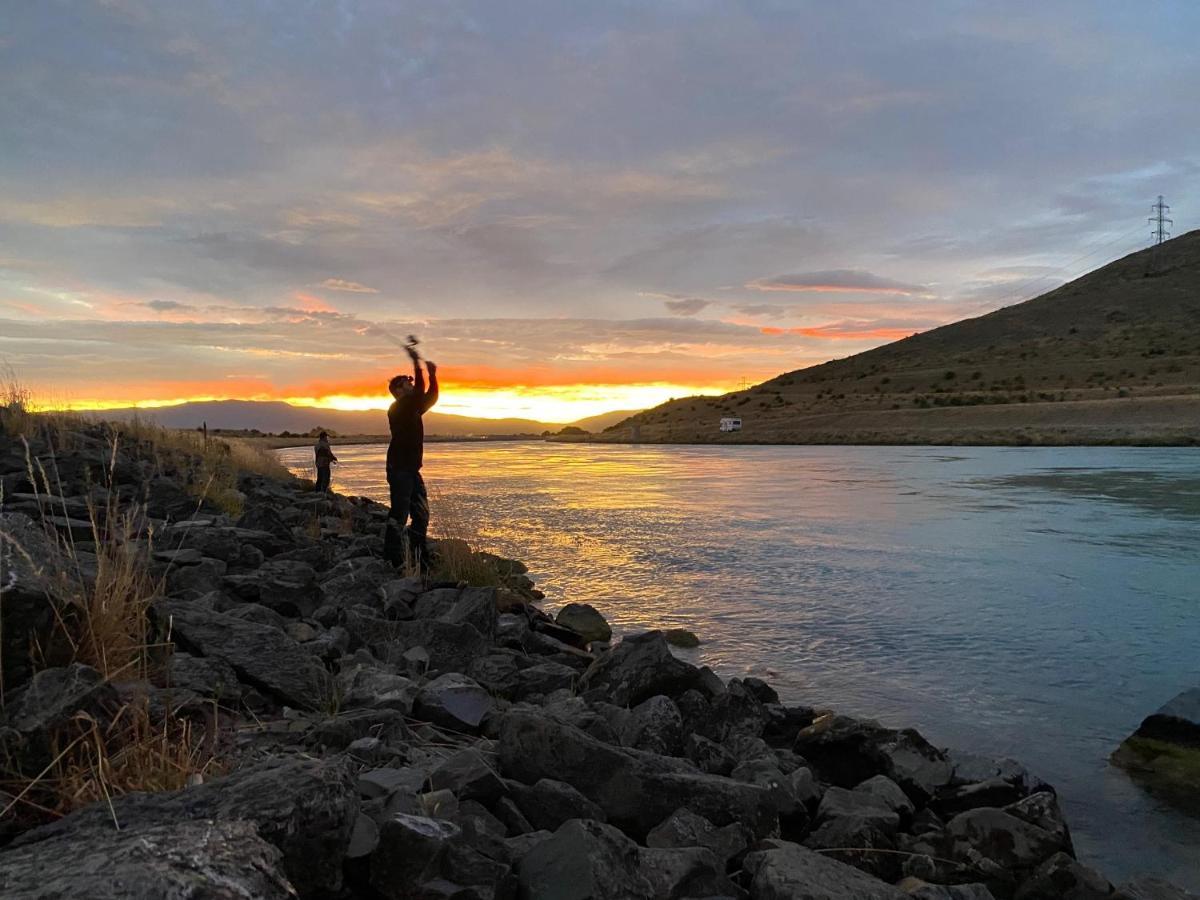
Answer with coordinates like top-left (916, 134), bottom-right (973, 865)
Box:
top-left (0, 384), bottom-right (231, 824)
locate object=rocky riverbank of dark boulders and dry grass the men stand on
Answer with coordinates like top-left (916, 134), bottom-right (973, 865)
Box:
top-left (0, 426), bottom-right (1188, 900)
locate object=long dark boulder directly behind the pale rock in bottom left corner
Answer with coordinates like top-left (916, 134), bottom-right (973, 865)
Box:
top-left (12, 758), bottom-right (359, 898)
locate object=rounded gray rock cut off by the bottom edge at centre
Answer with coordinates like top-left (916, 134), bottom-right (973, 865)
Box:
top-left (517, 820), bottom-right (656, 900)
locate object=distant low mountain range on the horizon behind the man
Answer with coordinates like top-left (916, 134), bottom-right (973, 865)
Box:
top-left (85, 400), bottom-right (634, 437)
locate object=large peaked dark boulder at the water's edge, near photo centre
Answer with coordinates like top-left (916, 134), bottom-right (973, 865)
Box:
top-left (580, 631), bottom-right (697, 706)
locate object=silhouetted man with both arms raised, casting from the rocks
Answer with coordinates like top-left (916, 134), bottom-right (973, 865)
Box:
top-left (383, 336), bottom-right (438, 571)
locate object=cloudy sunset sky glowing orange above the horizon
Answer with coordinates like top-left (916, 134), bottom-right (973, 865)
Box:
top-left (0, 0), bottom-right (1200, 421)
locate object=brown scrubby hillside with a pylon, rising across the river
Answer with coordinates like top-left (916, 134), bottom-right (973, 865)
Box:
top-left (604, 230), bottom-right (1200, 444)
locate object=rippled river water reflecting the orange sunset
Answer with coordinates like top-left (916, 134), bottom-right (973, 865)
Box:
top-left (281, 443), bottom-right (1200, 890)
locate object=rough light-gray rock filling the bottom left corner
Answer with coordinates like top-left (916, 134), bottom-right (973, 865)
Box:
top-left (0, 820), bottom-right (296, 900)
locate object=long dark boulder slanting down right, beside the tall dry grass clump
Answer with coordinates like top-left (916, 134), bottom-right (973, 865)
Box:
top-left (155, 600), bottom-right (334, 709)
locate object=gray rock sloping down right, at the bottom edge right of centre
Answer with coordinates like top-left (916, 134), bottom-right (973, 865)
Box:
top-left (742, 841), bottom-right (906, 900)
